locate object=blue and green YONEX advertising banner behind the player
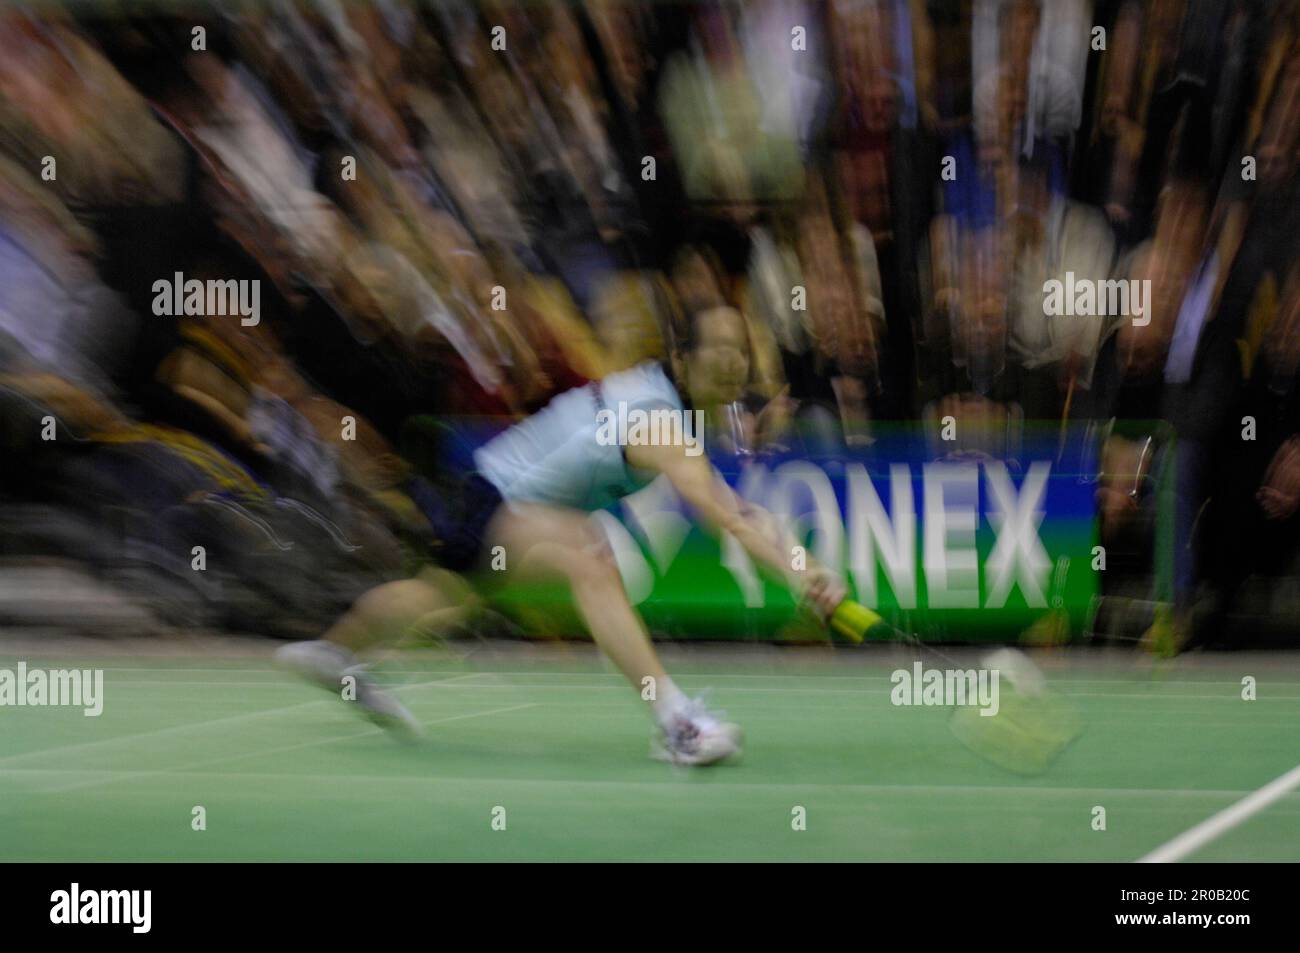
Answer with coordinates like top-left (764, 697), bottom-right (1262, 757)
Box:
top-left (478, 428), bottom-right (1100, 641)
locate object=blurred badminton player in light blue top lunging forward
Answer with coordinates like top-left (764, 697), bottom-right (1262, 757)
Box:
top-left (277, 307), bottom-right (845, 764)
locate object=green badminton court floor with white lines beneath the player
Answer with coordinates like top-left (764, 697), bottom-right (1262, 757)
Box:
top-left (0, 642), bottom-right (1300, 861)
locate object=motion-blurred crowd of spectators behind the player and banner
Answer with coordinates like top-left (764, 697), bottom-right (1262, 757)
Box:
top-left (0, 0), bottom-right (1300, 642)
